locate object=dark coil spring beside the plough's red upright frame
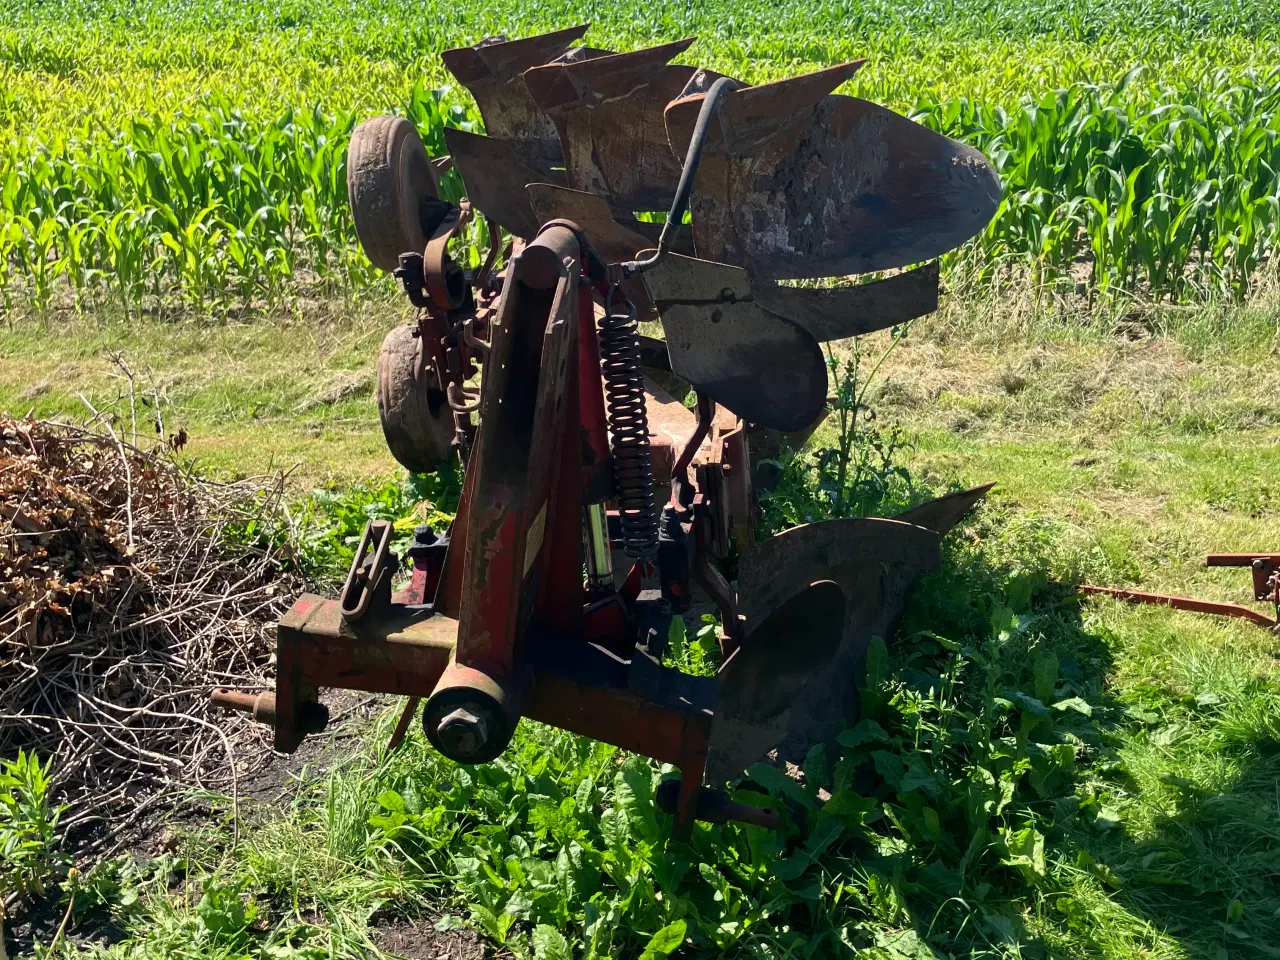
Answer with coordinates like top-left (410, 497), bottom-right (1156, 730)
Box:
top-left (600, 285), bottom-right (658, 559)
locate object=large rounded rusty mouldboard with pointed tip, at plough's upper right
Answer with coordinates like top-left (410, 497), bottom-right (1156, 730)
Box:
top-left (667, 64), bottom-right (1000, 279)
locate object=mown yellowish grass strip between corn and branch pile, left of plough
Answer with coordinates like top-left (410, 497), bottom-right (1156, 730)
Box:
top-left (0, 297), bottom-right (408, 490)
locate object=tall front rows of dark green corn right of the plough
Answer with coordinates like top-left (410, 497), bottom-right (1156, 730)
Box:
top-left (915, 69), bottom-right (1280, 300)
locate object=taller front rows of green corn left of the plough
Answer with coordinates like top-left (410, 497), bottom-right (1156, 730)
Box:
top-left (0, 88), bottom-right (465, 314)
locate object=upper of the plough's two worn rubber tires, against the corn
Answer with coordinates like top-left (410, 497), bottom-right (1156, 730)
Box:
top-left (347, 116), bottom-right (440, 271)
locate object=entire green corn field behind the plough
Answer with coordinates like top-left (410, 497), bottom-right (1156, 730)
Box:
top-left (0, 0), bottom-right (1280, 314)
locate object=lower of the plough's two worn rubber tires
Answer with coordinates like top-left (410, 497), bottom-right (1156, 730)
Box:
top-left (378, 324), bottom-right (454, 474)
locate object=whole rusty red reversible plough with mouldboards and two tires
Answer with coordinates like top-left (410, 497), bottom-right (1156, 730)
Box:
top-left (214, 27), bottom-right (1000, 838)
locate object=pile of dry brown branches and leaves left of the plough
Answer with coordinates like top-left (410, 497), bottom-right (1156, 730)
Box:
top-left (0, 417), bottom-right (296, 845)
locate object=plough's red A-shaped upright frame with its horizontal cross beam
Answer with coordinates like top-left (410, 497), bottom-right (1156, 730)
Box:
top-left (275, 225), bottom-right (712, 838)
